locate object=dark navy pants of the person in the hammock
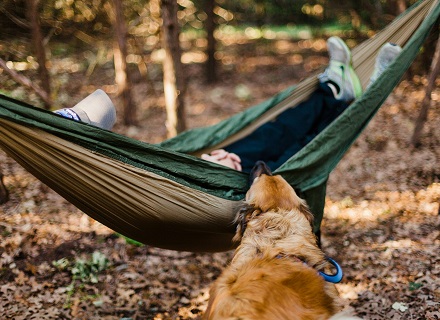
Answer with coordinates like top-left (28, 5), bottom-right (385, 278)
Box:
top-left (224, 83), bottom-right (349, 172)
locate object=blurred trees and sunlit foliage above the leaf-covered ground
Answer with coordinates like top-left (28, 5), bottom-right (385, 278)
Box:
top-left (0, 0), bottom-right (432, 132)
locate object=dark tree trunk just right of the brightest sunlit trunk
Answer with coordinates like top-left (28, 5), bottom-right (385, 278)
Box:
top-left (205, 0), bottom-right (217, 83)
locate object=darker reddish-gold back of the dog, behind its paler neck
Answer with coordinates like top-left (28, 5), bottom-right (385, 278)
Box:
top-left (205, 257), bottom-right (335, 320)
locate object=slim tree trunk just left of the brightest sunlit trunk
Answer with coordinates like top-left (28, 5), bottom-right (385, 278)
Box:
top-left (113, 0), bottom-right (137, 125)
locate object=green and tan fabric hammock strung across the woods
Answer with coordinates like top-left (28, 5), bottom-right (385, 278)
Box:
top-left (0, 0), bottom-right (440, 251)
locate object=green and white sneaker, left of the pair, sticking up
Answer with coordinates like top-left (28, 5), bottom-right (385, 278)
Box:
top-left (318, 37), bottom-right (362, 101)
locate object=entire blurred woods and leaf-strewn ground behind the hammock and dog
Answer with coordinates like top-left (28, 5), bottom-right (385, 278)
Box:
top-left (0, 0), bottom-right (440, 320)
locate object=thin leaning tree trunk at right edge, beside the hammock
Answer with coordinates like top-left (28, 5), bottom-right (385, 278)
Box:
top-left (411, 36), bottom-right (440, 147)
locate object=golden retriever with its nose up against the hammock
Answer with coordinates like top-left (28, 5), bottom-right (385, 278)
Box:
top-left (204, 161), bottom-right (358, 320)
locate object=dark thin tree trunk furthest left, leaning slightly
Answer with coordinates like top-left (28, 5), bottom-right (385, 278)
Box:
top-left (28, 0), bottom-right (51, 109)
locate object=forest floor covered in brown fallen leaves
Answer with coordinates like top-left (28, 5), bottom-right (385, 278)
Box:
top-left (0, 35), bottom-right (440, 320)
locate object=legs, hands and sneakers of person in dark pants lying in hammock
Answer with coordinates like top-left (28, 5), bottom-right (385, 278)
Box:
top-left (201, 37), bottom-right (402, 172)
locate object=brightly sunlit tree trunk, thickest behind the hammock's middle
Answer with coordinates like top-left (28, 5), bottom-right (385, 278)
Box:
top-left (162, 0), bottom-right (186, 137)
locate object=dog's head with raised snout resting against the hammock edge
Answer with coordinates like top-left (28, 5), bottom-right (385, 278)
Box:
top-left (234, 161), bottom-right (313, 241)
